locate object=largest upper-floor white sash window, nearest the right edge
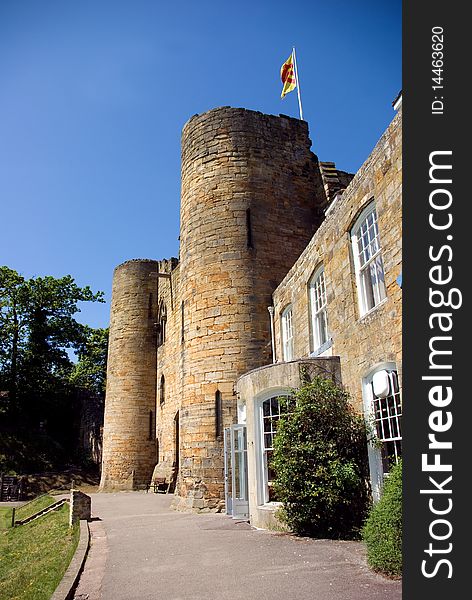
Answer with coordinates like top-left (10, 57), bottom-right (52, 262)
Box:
top-left (351, 203), bottom-right (387, 316)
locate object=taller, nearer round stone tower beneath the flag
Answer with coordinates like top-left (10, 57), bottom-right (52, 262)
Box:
top-left (177, 107), bottom-right (325, 509)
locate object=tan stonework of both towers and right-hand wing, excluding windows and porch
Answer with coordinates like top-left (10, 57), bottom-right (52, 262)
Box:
top-left (101, 107), bottom-right (401, 511)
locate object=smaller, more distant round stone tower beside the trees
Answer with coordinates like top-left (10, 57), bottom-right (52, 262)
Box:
top-left (100, 260), bottom-right (158, 490)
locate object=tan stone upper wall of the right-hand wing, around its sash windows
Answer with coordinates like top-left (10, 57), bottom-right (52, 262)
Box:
top-left (273, 112), bottom-right (402, 410)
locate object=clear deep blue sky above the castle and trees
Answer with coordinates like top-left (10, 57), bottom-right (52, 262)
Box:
top-left (0, 0), bottom-right (401, 327)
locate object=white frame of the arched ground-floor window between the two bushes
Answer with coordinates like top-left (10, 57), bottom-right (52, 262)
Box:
top-left (362, 362), bottom-right (402, 501)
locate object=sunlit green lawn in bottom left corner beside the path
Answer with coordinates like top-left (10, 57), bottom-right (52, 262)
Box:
top-left (0, 505), bottom-right (79, 600)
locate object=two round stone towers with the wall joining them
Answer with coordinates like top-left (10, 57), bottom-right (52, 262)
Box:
top-left (101, 107), bottom-right (334, 510)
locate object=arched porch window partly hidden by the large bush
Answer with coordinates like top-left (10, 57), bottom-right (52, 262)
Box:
top-left (261, 394), bottom-right (287, 502)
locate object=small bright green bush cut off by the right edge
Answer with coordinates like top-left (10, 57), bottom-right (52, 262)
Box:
top-left (362, 461), bottom-right (402, 575)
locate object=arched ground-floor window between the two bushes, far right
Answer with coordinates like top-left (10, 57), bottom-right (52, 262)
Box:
top-left (364, 364), bottom-right (402, 499)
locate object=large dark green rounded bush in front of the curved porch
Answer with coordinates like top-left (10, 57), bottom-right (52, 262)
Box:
top-left (272, 377), bottom-right (369, 539)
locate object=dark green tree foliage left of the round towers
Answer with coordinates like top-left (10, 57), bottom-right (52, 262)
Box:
top-left (0, 266), bottom-right (106, 471)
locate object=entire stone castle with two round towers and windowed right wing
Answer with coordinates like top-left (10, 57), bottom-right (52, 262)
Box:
top-left (100, 107), bottom-right (401, 527)
